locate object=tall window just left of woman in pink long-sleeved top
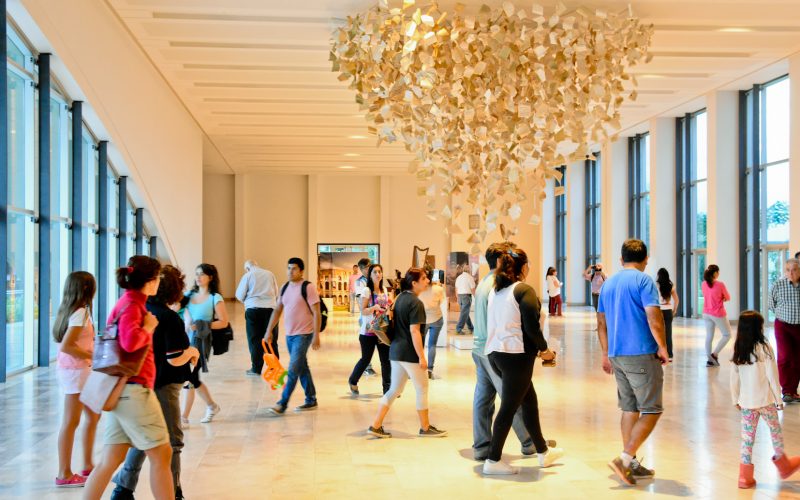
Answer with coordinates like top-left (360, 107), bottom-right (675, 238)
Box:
top-left (674, 110), bottom-right (708, 317)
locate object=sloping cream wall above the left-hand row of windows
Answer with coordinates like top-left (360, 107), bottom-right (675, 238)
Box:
top-left (19, 0), bottom-right (203, 269)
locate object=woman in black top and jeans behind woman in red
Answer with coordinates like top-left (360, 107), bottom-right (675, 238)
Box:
top-left (111, 266), bottom-right (200, 500)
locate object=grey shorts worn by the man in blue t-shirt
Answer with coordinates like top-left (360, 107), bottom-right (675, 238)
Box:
top-left (610, 354), bottom-right (664, 413)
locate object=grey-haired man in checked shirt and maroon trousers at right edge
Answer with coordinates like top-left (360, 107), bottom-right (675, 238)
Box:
top-left (769, 259), bottom-right (800, 403)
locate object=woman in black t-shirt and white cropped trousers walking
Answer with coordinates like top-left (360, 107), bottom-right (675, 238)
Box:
top-left (367, 267), bottom-right (447, 438)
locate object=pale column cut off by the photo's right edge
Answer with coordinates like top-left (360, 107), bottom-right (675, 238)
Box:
top-left (789, 53), bottom-right (800, 257)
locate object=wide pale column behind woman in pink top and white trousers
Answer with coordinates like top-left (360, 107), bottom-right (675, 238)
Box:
top-left (706, 91), bottom-right (739, 319)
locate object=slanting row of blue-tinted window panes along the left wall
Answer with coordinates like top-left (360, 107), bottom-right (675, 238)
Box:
top-left (0, 21), bottom-right (158, 381)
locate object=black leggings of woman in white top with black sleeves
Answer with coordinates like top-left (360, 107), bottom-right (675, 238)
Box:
top-left (489, 352), bottom-right (547, 462)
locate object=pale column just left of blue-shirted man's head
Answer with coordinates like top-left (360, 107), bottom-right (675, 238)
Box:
top-left (600, 137), bottom-right (628, 274)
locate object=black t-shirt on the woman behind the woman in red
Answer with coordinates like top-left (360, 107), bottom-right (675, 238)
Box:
top-left (147, 301), bottom-right (191, 388)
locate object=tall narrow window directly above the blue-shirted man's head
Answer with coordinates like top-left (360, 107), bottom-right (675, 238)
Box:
top-left (628, 134), bottom-right (650, 247)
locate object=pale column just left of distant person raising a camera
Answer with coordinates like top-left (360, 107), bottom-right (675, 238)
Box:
top-left (564, 160), bottom-right (586, 304)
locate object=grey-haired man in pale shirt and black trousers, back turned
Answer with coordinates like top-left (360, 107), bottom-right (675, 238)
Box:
top-left (236, 260), bottom-right (278, 377)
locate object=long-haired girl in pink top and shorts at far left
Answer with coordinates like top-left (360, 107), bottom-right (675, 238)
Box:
top-left (53, 271), bottom-right (100, 488)
